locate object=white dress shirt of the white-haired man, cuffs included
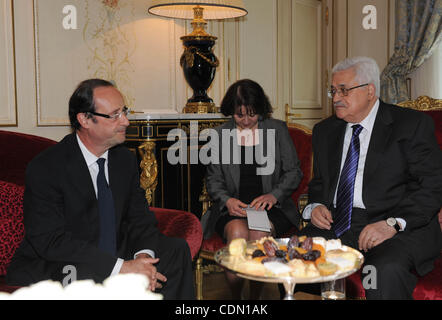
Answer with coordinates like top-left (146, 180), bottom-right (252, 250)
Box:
top-left (302, 99), bottom-right (406, 230)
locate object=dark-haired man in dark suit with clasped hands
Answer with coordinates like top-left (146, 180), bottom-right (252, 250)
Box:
top-left (7, 79), bottom-right (194, 299)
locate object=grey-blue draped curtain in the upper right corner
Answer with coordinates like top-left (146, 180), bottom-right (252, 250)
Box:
top-left (381, 0), bottom-right (442, 103)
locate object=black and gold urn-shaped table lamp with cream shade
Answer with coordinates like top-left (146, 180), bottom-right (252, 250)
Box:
top-left (149, 0), bottom-right (248, 113)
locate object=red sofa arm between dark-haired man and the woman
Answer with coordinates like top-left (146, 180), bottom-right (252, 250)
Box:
top-left (150, 207), bottom-right (203, 258)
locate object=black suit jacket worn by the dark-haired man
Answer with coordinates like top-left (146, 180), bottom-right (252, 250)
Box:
top-left (7, 134), bottom-right (159, 285)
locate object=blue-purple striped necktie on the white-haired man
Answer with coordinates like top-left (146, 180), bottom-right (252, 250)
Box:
top-left (334, 124), bottom-right (363, 238)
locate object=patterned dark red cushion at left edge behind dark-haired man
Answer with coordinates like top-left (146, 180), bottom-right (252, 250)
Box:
top-left (0, 181), bottom-right (24, 275)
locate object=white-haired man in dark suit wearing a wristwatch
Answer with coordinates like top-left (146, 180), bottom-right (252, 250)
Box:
top-left (303, 57), bottom-right (442, 299)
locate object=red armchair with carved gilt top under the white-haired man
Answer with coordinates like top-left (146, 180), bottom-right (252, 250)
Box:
top-left (346, 96), bottom-right (442, 300)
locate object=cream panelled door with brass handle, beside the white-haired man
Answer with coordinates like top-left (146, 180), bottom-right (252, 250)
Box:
top-left (278, 0), bottom-right (327, 127)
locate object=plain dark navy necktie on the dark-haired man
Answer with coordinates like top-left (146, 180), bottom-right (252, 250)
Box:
top-left (97, 158), bottom-right (117, 256)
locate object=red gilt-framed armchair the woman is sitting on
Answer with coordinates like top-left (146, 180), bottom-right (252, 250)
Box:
top-left (195, 124), bottom-right (313, 300)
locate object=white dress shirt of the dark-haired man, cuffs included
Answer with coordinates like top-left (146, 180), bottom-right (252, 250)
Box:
top-left (76, 134), bottom-right (155, 276)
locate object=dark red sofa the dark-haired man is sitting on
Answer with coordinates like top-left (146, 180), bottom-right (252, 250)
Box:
top-left (0, 130), bottom-right (202, 292)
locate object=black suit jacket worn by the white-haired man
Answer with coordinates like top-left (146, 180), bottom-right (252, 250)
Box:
top-left (309, 101), bottom-right (442, 273)
